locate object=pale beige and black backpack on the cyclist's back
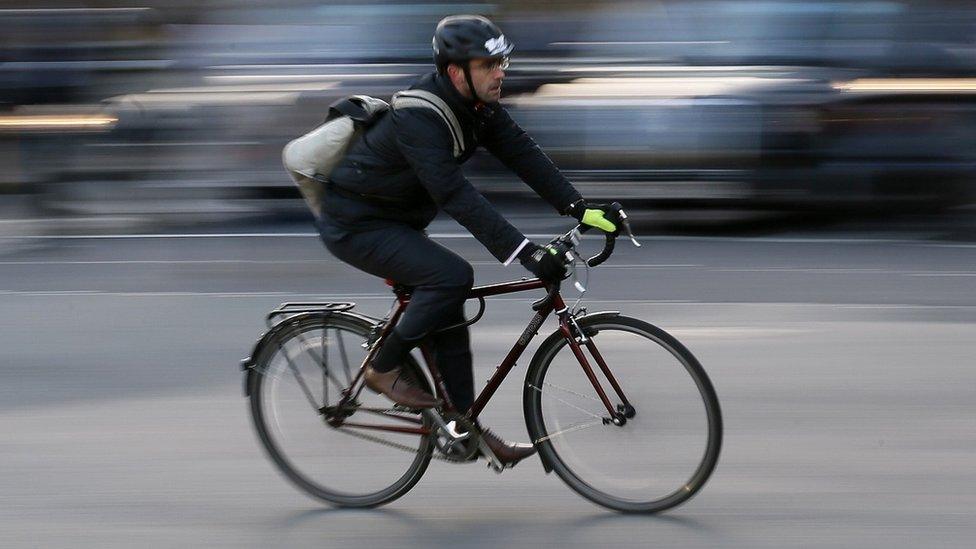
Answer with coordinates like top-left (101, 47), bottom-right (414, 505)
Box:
top-left (281, 90), bottom-right (464, 219)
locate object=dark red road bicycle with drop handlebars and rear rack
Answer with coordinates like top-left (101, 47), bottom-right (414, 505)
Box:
top-left (242, 210), bottom-right (722, 513)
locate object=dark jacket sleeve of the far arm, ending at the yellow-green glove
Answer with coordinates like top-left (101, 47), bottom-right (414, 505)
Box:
top-left (482, 106), bottom-right (583, 214)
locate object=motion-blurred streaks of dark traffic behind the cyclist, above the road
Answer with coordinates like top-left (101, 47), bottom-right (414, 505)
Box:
top-left (0, 0), bottom-right (976, 232)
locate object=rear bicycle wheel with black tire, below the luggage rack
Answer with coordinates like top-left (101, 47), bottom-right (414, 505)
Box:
top-left (248, 313), bottom-right (433, 507)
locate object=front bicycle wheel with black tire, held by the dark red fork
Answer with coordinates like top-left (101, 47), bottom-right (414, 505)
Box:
top-left (524, 315), bottom-right (722, 513)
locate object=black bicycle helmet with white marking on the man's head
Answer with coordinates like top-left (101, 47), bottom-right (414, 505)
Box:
top-left (433, 15), bottom-right (515, 74)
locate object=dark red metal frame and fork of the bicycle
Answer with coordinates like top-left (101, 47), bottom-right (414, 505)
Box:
top-left (337, 278), bottom-right (630, 435)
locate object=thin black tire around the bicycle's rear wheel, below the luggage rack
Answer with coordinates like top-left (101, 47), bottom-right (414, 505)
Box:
top-left (247, 313), bottom-right (433, 507)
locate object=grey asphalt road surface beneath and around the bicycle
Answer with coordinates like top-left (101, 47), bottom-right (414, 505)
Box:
top-left (0, 216), bottom-right (976, 548)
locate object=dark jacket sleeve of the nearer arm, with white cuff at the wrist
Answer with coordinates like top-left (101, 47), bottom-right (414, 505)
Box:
top-left (393, 108), bottom-right (526, 264)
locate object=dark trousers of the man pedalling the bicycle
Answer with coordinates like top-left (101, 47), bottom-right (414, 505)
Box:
top-left (319, 220), bottom-right (474, 412)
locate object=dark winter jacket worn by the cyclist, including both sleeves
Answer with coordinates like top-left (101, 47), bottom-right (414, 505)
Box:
top-left (323, 74), bottom-right (580, 261)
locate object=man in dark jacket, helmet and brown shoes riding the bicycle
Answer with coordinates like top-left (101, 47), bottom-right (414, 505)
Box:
top-left (317, 15), bottom-right (617, 464)
